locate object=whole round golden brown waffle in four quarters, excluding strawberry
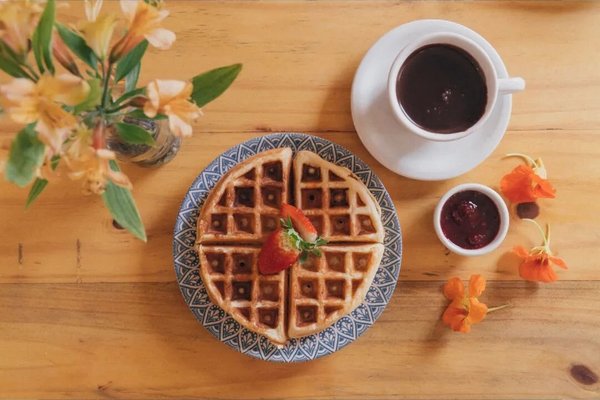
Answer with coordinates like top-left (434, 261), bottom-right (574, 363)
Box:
top-left (197, 148), bottom-right (383, 345)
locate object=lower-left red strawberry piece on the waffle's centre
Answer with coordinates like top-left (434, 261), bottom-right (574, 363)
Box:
top-left (258, 228), bottom-right (300, 274)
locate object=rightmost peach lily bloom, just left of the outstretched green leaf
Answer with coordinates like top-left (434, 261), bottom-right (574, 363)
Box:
top-left (144, 79), bottom-right (202, 136)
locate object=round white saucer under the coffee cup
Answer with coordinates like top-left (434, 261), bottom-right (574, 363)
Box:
top-left (352, 19), bottom-right (512, 181)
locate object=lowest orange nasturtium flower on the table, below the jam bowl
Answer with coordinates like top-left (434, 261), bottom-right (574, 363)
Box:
top-left (442, 275), bottom-right (488, 333)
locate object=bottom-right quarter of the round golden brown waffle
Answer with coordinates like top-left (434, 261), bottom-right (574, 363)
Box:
top-left (288, 243), bottom-right (383, 338)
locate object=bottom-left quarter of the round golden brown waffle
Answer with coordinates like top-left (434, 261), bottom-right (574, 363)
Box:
top-left (199, 245), bottom-right (287, 344)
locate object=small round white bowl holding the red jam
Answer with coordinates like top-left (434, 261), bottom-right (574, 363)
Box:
top-left (433, 183), bottom-right (510, 256)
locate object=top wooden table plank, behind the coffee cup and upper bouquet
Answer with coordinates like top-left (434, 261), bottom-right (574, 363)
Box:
top-left (0, 0), bottom-right (600, 136)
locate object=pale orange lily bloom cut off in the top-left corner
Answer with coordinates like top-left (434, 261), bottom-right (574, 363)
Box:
top-left (0, 0), bottom-right (43, 54)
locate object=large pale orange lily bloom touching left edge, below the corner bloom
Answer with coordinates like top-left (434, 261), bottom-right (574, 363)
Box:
top-left (0, 74), bottom-right (90, 154)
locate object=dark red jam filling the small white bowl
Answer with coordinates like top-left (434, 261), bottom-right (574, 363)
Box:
top-left (440, 190), bottom-right (500, 250)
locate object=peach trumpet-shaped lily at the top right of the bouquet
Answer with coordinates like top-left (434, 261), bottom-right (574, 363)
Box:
top-left (111, 0), bottom-right (175, 61)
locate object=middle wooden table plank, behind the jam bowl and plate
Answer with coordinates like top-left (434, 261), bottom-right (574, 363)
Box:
top-left (0, 131), bottom-right (600, 282)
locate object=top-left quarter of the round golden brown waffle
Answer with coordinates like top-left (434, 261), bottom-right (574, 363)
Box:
top-left (197, 148), bottom-right (292, 243)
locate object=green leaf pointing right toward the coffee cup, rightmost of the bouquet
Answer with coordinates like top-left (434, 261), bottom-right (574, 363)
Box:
top-left (191, 64), bottom-right (242, 107)
